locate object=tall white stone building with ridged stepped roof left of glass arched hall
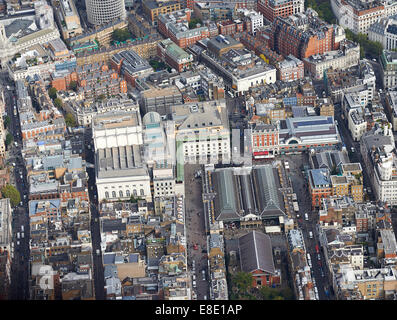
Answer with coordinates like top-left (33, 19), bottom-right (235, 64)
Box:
top-left (92, 110), bottom-right (152, 202)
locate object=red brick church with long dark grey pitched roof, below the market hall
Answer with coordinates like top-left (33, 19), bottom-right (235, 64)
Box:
top-left (238, 231), bottom-right (281, 287)
